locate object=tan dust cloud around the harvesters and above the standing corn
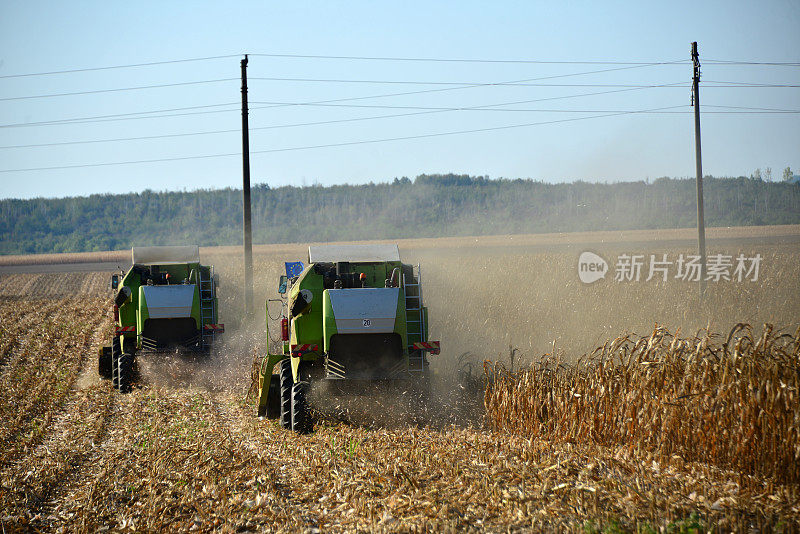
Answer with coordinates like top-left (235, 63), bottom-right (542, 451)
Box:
top-left (139, 228), bottom-right (800, 416)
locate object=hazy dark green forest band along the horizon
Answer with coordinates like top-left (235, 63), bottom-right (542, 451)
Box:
top-left (0, 174), bottom-right (800, 254)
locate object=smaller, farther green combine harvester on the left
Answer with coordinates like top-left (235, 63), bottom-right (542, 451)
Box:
top-left (98, 246), bottom-right (225, 393)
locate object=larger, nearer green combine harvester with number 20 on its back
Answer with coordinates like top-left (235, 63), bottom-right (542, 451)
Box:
top-left (258, 245), bottom-right (440, 433)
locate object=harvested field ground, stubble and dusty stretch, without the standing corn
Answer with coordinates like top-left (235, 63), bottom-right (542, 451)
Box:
top-left (0, 232), bottom-right (800, 532)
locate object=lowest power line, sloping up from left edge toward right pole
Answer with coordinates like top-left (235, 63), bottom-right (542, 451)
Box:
top-left (0, 106), bottom-right (684, 173)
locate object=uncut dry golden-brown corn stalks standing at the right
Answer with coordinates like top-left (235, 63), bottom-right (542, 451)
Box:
top-left (485, 324), bottom-right (800, 484)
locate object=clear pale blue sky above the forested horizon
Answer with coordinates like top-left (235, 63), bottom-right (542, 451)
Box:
top-left (0, 1), bottom-right (800, 198)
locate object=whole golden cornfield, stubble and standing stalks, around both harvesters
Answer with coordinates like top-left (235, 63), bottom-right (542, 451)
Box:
top-left (0, 232), bottom-right (800, 532)
